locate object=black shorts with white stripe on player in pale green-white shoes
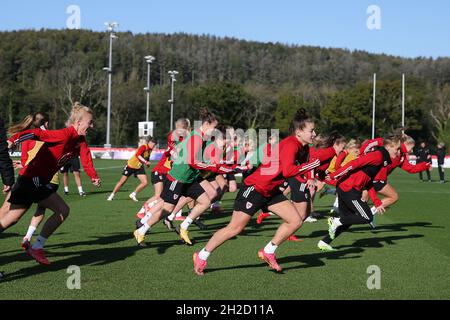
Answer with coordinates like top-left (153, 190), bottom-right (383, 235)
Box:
top-left (336, 187), bottom-right (373, 223)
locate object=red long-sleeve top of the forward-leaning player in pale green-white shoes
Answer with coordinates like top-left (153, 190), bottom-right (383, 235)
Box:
top-left (330, 148), bottom-right (392, 192)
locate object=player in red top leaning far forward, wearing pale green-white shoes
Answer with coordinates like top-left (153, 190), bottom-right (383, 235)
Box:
top-left (317, 135), bottom-right (401, 251)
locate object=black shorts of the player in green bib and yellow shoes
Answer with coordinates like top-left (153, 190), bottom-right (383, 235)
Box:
top-left (161, 177), bottom-right (205, 205)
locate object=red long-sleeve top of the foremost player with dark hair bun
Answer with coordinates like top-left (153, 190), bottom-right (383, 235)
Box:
top-left (244, 136), bottom-right (320, 197)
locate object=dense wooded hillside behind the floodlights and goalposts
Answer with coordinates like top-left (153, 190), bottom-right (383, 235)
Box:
top-left (0, 30), bottom-right (450, 146)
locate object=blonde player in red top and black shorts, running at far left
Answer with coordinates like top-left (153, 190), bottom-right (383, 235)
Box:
top-left (0, 103), bottom-right (100, 265)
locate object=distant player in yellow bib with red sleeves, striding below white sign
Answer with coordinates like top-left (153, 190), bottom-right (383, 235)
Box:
top-left (107, 136), bottom-right (156, 202)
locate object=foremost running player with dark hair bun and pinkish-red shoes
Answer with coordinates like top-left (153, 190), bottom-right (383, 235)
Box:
top-left (193, 109), bottom-right (320, 275)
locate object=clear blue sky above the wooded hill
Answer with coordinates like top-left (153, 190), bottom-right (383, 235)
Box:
top-left (0, 0), bottom-right (450, 58)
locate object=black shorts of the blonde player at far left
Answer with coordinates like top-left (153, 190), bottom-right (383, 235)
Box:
top-left (8, 176), bottom-right (55, 207)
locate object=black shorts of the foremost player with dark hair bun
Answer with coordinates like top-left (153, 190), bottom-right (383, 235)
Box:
top-left (234, 183), bottom-right (287, 216)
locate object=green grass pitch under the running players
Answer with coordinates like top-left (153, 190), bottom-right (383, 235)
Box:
top-left (0, 160), bottom-right (450, 300)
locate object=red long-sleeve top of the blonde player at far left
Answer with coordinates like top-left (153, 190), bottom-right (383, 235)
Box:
top-left (8, 126), bottom-right (98, 183)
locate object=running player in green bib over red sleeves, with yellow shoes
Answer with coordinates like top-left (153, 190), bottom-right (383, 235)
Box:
top-left (134, 108), bottom-right (237, 245)
